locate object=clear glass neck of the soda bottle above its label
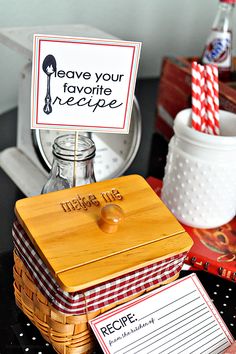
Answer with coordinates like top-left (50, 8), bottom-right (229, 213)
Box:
top-left (213, 1), bottom-right (234, 32)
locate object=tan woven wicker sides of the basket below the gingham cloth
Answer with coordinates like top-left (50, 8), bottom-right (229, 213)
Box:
top-left (14, 252), bottom-right (179, 354)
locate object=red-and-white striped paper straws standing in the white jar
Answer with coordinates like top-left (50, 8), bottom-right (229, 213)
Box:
top-left (192, 61), bottom-right (220, 135)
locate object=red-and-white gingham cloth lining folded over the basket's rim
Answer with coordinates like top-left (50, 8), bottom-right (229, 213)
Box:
top-left (12, 221), bottom-right (187, 315)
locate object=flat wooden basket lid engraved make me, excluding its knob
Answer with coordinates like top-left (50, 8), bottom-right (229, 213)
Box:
top-left (15, 175), bottom-right (192, 292)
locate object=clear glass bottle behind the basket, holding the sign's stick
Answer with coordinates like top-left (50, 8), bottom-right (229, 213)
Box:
top-left (42, 134), bottom-right (96, 194)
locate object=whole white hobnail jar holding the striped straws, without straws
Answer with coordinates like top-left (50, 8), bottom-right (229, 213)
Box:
top-left (162, 109), bottom-right (236, 228)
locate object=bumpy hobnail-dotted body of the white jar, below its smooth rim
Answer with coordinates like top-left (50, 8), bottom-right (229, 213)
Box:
top-left (162, 139), bottom-right (236, 228)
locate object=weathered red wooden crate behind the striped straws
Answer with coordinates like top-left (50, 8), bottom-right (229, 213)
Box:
top-left (156, 57), bottom-right (236, 141)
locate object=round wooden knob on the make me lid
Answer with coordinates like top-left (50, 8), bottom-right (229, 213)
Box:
top-left (98, 204), bottom-right (124, 234)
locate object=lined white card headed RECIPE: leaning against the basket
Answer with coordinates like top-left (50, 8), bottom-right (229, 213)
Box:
top-left (90, 274), bottom-right (234, 354)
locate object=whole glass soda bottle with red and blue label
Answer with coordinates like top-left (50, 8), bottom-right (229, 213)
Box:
top-left (202, 0), bottom-right (236, 81)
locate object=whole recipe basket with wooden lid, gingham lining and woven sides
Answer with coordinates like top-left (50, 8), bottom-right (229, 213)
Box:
top-left (13, 175), bottom-right (192, 353)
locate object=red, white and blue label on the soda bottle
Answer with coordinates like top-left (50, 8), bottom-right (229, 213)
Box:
top-left (202, 31), bottom-right (232, 69)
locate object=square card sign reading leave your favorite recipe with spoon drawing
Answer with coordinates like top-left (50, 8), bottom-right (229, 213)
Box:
top-left (31, 34), bottom-right (141, 134)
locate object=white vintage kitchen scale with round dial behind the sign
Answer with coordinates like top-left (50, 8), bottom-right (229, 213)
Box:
top-left (0, 25), bottom-right (141, 196)
